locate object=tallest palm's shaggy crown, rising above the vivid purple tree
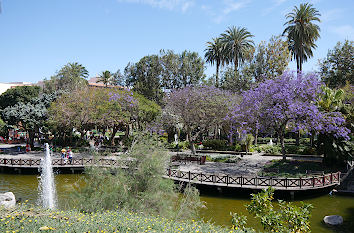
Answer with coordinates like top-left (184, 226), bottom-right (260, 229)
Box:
top-left (283, 3), bottom-right (321, 72)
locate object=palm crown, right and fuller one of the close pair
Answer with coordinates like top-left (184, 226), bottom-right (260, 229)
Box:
top-left (221, 26), bottom-right (254, 71)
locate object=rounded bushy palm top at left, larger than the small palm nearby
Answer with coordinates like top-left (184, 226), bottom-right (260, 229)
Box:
top-left (44, 62), bottom-right (89, 93)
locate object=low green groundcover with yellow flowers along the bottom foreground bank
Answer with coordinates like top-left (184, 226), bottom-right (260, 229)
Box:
top-left (0, 204), bottom-right (243, 233)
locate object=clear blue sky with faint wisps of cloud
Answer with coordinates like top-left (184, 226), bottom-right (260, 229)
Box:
top-left (0, 0), bottom-right (354, 82)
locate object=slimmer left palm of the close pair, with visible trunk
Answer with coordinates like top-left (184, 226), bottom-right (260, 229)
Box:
top-left (205, 37), bottom-right (226, 87)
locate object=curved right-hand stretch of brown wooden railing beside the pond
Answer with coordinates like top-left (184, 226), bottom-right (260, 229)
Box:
top-left (166, 168), bottom-right (340, 189)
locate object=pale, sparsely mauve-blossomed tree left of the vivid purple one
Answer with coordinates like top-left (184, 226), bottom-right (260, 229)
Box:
top-left (165, 86), bottom-right (236, 154)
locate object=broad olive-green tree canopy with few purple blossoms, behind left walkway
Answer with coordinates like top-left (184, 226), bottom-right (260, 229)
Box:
top-left (50, 88), bottom-right (160, 146)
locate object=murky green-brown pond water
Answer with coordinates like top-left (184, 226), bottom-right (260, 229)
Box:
top-left (0, 174), bottom-right (354, 233)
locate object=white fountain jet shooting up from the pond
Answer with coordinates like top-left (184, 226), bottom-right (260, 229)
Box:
top-left (38, 143), bottom-right (57, 209)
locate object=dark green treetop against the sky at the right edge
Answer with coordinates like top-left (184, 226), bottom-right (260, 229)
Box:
top-left (320, 40), bottom-right (354, 88)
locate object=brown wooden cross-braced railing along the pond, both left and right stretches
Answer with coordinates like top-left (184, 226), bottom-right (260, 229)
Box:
top-left (0, 158), bottom-right (341, 191)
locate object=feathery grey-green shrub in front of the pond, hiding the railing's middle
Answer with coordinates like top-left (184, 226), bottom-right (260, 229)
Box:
top-left (70, 136), bottom-right (202, 219)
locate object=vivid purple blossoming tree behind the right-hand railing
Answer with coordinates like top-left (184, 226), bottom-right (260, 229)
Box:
top-left (227, 72), bottom-right (349, 160)
